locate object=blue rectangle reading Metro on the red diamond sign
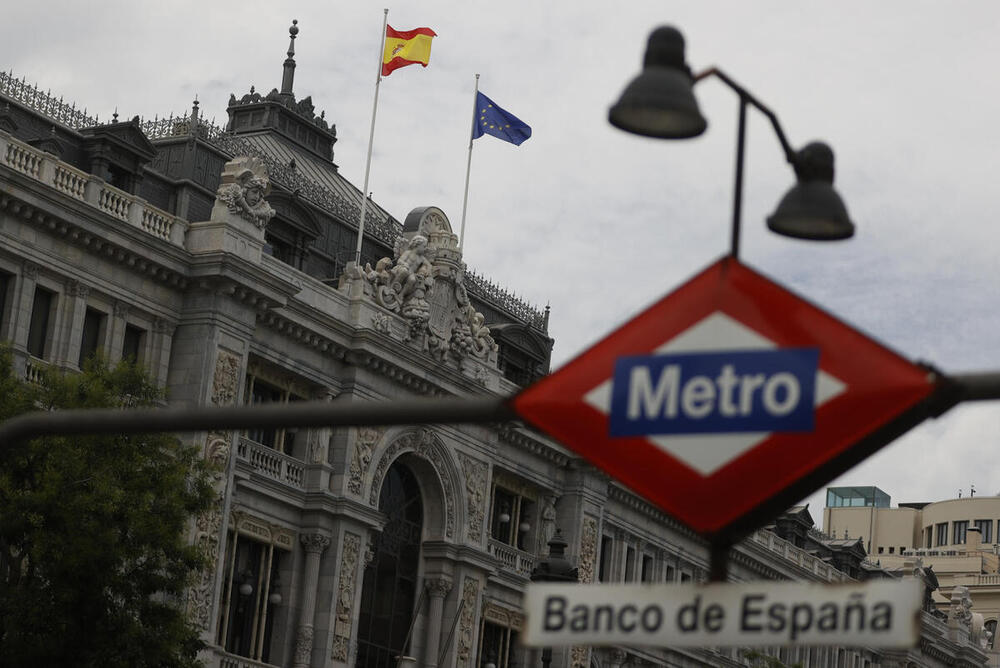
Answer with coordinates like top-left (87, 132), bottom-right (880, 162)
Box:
top-left (610, 348), bottom-right (819, 436)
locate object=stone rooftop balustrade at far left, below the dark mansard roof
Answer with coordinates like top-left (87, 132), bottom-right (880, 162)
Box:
top-left (0, 131), bottom-right (188, 246)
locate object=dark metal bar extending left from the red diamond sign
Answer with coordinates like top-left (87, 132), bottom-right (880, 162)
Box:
top-left (0, 397), bottom-right (517, 447)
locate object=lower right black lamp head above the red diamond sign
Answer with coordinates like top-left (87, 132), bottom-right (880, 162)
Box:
top-left (767, 142), bottom-right (854, 241)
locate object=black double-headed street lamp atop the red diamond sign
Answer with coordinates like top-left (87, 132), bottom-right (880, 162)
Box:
top-left (608, 26), bottom-right (854, 258)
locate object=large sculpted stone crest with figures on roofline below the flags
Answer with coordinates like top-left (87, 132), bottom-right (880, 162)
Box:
top-left (344, 207), bottom-right (499, 364)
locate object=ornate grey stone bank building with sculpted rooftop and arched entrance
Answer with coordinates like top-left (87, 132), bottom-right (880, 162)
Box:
top-left (0, 27), bottom-right (985, 668)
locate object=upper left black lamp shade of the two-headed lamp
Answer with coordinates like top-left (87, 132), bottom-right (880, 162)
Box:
top-left (608, 26), bottom-right (708, 139)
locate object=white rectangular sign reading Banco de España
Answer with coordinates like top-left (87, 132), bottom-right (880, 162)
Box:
top-left (522, 578), bottom-right (923, 648)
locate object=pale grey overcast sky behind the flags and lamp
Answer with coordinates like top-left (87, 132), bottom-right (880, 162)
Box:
top-left (0, 0), bottom-right (1000, 523)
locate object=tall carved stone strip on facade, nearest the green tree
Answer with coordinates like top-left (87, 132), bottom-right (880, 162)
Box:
top-left (187, 348), bottom-right (241, 631)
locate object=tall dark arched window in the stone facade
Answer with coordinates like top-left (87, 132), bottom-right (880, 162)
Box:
top-left (357, 462), bottom-right (424, 668)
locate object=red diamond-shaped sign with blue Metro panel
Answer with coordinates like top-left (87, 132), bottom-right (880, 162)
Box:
top-left (512, 257), bottom-right (935, 537)
